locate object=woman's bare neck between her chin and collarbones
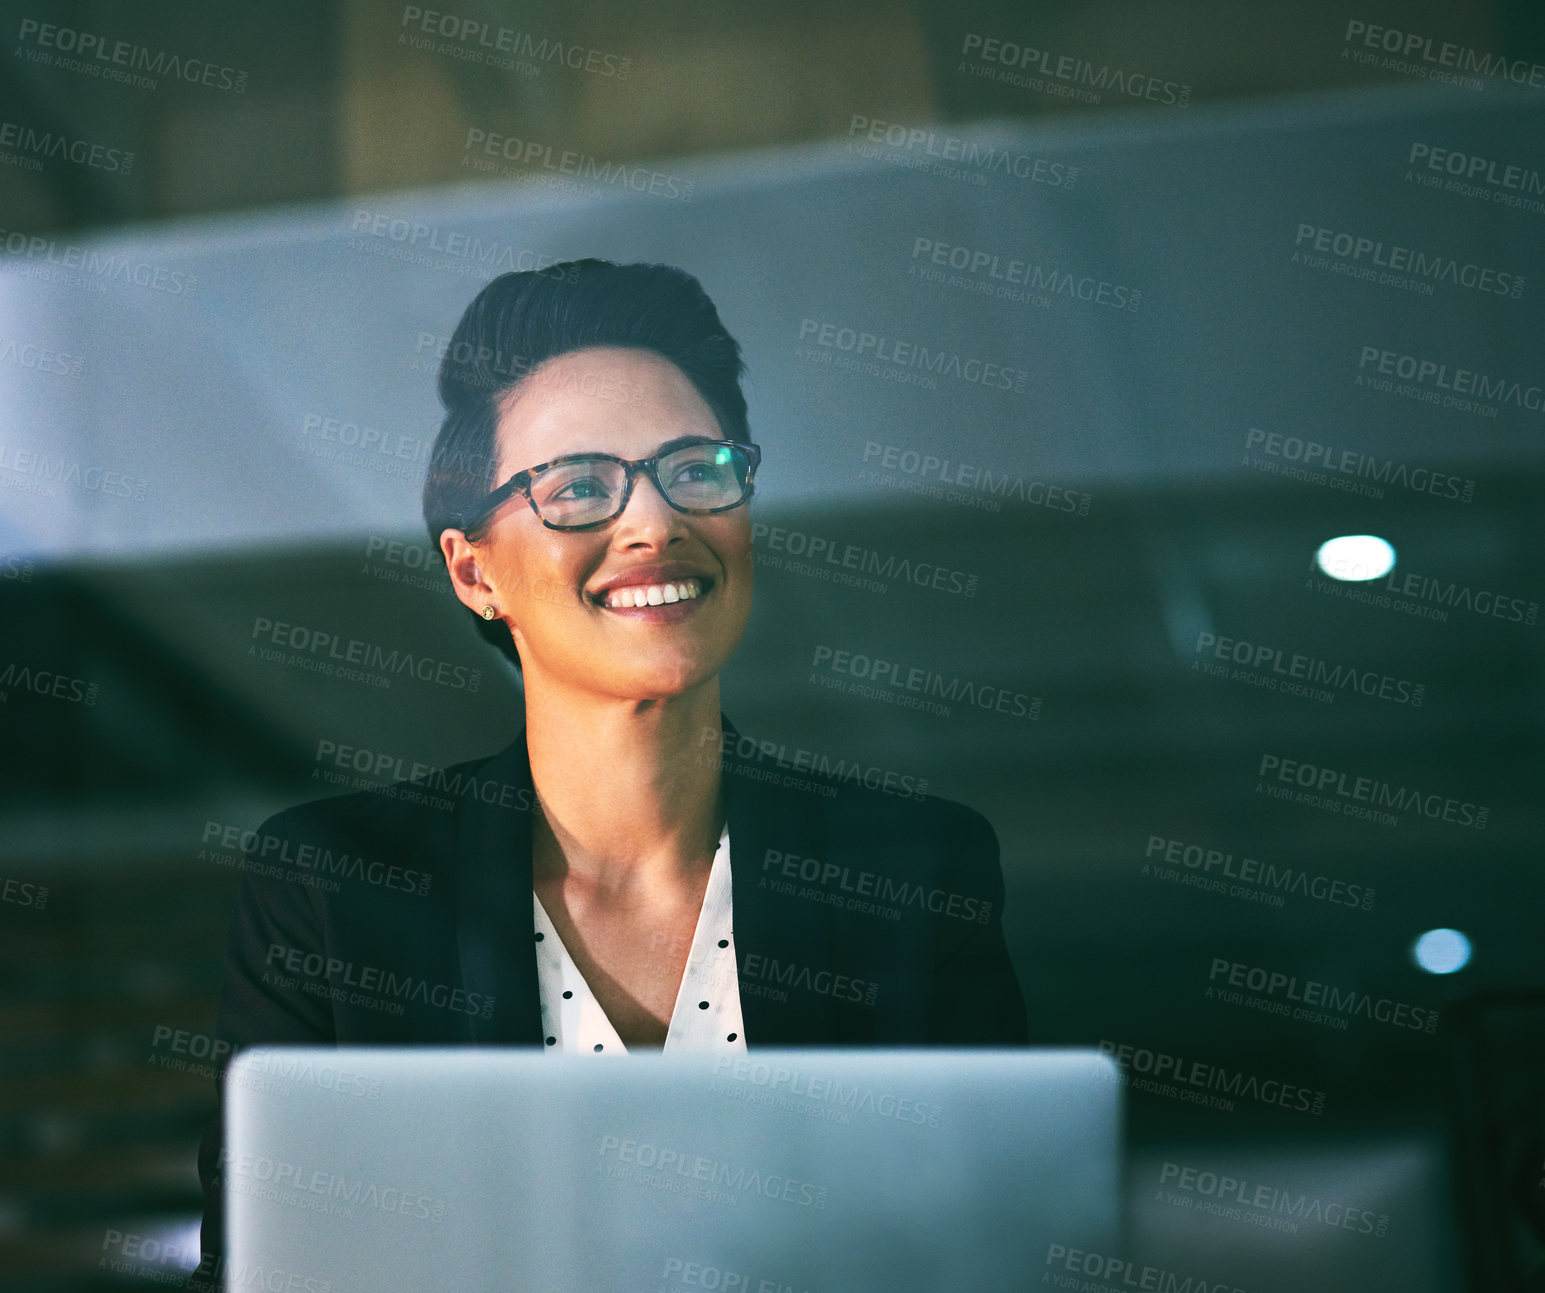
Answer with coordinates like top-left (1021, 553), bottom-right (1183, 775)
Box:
top-left (525, 678), bottom-right (725, 896)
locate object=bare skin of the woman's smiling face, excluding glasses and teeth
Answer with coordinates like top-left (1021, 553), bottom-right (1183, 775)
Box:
top-left (457, 348), bottom-right (752, 700)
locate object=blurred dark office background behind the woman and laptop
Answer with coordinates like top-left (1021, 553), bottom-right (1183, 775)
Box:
top-left (0, 0), bottom-right (1545, 1293)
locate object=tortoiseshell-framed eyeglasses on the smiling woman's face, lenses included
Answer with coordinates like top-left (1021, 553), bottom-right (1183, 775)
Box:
top-left (462, 436), bottom-right (762, 538)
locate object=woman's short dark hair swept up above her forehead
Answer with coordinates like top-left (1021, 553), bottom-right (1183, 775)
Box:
top-left (423, 260), bottom-right (751, 669)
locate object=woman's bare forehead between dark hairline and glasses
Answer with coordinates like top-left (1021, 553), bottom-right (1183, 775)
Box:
top-left (497, 348), bottom-right (720, 477)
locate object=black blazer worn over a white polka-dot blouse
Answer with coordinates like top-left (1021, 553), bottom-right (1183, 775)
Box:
top-left (190, 720), bottom-right (1027, 1271)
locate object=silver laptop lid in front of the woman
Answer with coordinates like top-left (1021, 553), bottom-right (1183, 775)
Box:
top-left (222, 1047), bottom-right (1122, 1293)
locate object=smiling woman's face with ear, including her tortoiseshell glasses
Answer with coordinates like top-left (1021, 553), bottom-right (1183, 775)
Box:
top-left (436, 348), bottom-right (759, 694)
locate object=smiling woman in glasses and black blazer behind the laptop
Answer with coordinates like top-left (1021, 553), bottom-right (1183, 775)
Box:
top-left (199, 260), bottom-right (1026, 1279)
